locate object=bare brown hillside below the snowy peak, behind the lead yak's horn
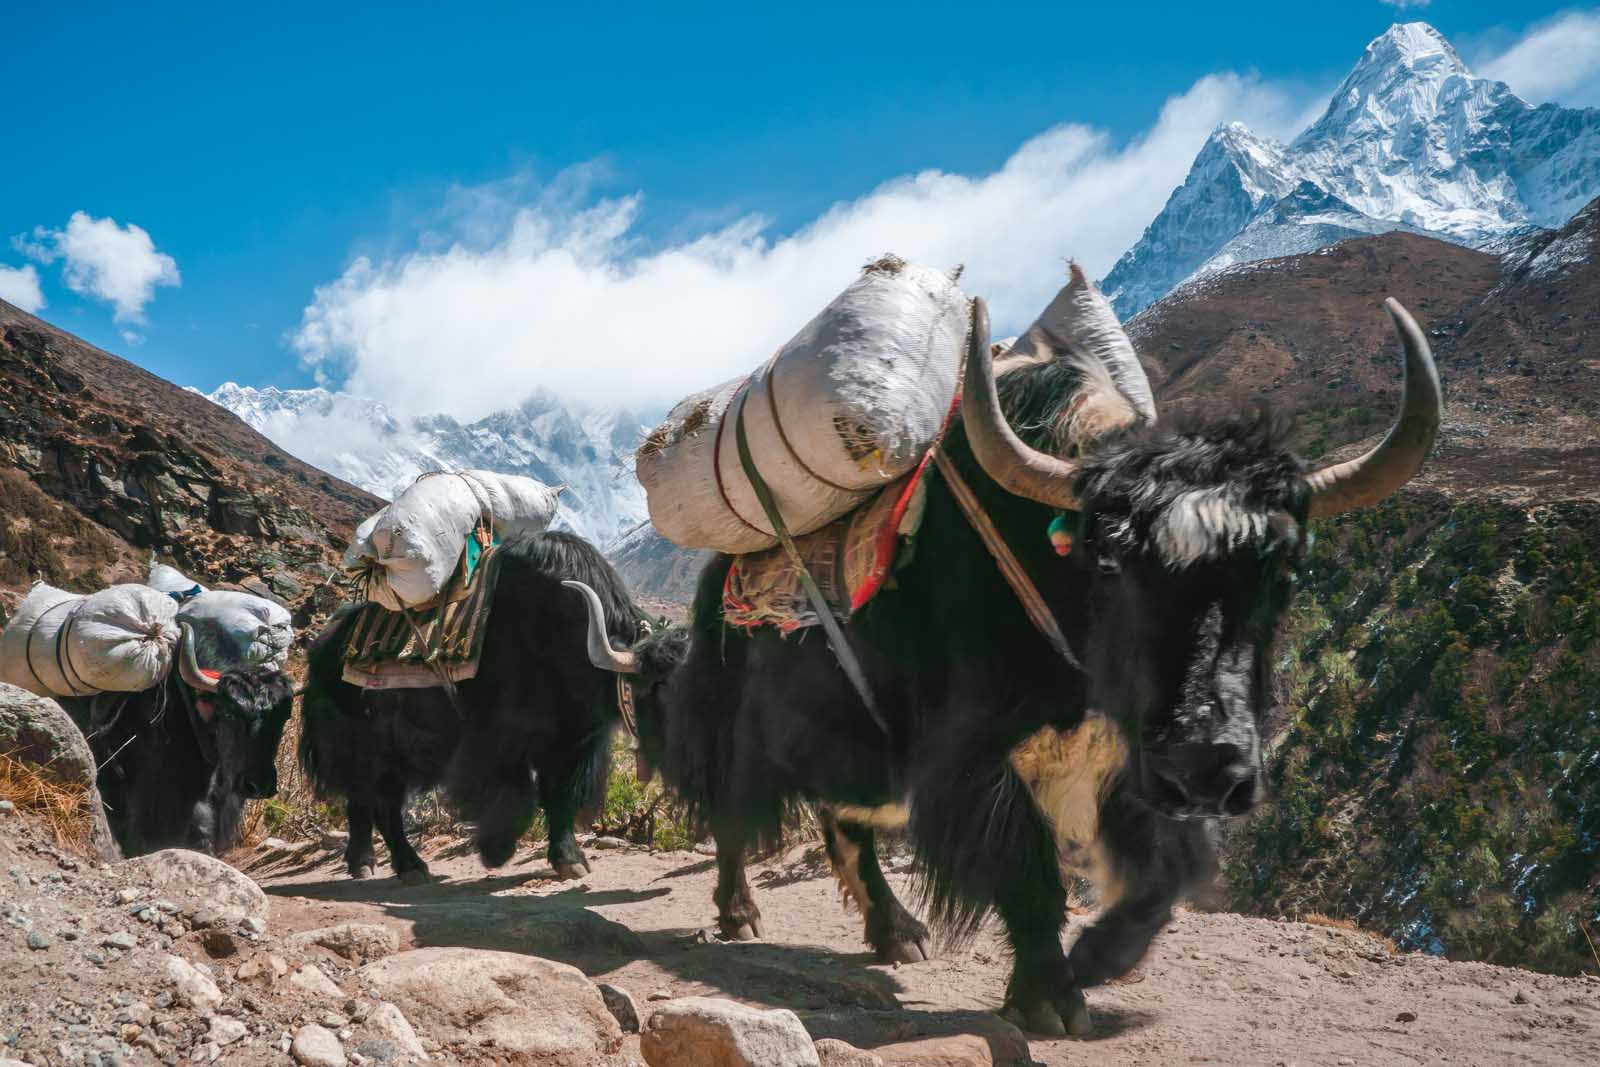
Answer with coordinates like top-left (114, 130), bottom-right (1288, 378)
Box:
top-left (1128, 220), bottom-right (1600, 502)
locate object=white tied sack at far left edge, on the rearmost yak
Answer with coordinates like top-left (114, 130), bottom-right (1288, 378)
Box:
top-left (0, 582), bottom-right (179, 696)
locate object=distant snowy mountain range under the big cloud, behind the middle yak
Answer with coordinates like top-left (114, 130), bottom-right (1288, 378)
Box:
top-left (210, 382), bottom-right (645, 545)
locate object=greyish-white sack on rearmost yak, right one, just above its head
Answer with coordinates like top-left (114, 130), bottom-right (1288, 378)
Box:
top-left (144, 560), bottom-right (294, 670)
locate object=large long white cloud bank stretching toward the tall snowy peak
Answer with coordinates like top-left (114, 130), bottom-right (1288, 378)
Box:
top-left (291, 74), bottom-right (1304, 419)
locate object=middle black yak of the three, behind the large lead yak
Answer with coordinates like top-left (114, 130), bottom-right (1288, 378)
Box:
top-left (299, 531), bottom-right (645, 881)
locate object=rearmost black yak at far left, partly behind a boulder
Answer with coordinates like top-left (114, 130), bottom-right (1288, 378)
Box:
top-left (62, 625), bottom-right (294, 856)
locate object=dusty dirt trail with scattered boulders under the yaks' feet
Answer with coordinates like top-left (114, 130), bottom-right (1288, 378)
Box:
top-left (0, 811), bottom-right (1600, 1067)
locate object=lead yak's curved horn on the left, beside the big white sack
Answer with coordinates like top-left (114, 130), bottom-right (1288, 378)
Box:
top-left (962, 298), bottom-right (1078, 510)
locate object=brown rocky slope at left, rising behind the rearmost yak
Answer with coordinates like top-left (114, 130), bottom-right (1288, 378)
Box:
top-left (0, 302), bottom-right (378, 617)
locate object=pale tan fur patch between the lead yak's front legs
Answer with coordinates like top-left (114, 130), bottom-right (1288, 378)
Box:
top-left (1011, 713), bottom-right (1128, 907)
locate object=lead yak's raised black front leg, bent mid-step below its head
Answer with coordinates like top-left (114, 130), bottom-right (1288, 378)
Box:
top-left (1067, 792), bottom-right (1216, 989)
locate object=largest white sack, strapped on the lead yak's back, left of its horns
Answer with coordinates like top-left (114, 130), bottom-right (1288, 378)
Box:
top-left (637, 256), bottom-right (971, 552)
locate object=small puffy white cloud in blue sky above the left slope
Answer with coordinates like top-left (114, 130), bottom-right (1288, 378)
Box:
top-left (16, 211), bottom-right (182, 323)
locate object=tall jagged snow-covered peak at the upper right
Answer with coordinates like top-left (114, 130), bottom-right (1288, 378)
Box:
top-left (1104, 22), bottom-right (1600, 317)
